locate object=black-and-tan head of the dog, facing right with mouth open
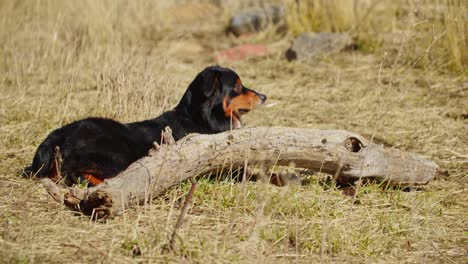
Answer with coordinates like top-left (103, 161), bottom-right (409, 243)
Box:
top-left (176, 66), bottom-right (266, 132)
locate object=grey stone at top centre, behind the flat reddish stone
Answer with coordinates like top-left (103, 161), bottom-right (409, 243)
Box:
top-left (227, 5), bottom-right (285, 36)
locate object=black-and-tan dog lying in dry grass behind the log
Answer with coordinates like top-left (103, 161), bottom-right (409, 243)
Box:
top-left (30, 66), bottom-right (267, 186)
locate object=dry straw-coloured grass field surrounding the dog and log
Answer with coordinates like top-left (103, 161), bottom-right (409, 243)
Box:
top-left (0, 0), bottom-right (468, 263)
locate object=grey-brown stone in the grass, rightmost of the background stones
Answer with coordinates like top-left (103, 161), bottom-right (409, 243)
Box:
top-left (286, 32), bottom-right (353, 61)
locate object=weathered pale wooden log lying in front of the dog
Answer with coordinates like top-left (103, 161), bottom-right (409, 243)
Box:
top-left (44, 127), bottom-right (438, 218)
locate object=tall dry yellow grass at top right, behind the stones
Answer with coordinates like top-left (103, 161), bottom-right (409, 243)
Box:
top-left (284, 0), bottom-right (468, 71)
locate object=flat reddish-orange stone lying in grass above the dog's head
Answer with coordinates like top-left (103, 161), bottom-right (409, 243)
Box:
top-left (215, 44), bottom-right (270, 62)
